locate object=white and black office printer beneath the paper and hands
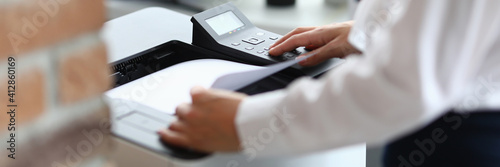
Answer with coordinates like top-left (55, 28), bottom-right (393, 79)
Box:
top-left (103, 3), bottom-right (362, 167)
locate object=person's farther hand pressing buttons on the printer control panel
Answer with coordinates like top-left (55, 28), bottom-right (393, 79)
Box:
top-left (269, 21), bottom-right (359, 66)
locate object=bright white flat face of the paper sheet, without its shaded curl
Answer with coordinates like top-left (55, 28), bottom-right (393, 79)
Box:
top-left (105, 59), bottom-right (263, 114)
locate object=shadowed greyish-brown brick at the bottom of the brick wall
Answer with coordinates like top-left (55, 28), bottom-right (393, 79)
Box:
top-left (0, 106), bottom-right (111, 167)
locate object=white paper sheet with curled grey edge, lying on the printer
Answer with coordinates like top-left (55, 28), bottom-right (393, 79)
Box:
top-left (105, 56), bottom-right (308, 114)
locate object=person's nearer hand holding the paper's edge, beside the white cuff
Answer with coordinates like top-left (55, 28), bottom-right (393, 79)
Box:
top-left (158, 87), bottom-right (246, 152)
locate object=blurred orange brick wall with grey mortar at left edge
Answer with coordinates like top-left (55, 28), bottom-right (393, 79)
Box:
top-left (0, 0), bottom-right (111, 167)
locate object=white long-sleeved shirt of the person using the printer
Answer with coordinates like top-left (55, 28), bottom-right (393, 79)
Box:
top-left (236, 0), bottom-right (500, 157)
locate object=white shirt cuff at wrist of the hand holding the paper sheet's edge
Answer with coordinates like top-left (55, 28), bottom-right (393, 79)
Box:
top-left (236, 90), bottom-right (289, 160)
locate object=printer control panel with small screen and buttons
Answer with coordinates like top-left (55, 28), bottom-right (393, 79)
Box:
top-left (191, 3), bottom-right (307, 65)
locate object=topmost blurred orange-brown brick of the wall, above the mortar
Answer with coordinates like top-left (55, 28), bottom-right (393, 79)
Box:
top-left (0, 0), bottom-right (106, 56)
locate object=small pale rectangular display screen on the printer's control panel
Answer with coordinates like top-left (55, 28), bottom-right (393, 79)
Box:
top-left (205, 11), bottom-right (245, 35)
